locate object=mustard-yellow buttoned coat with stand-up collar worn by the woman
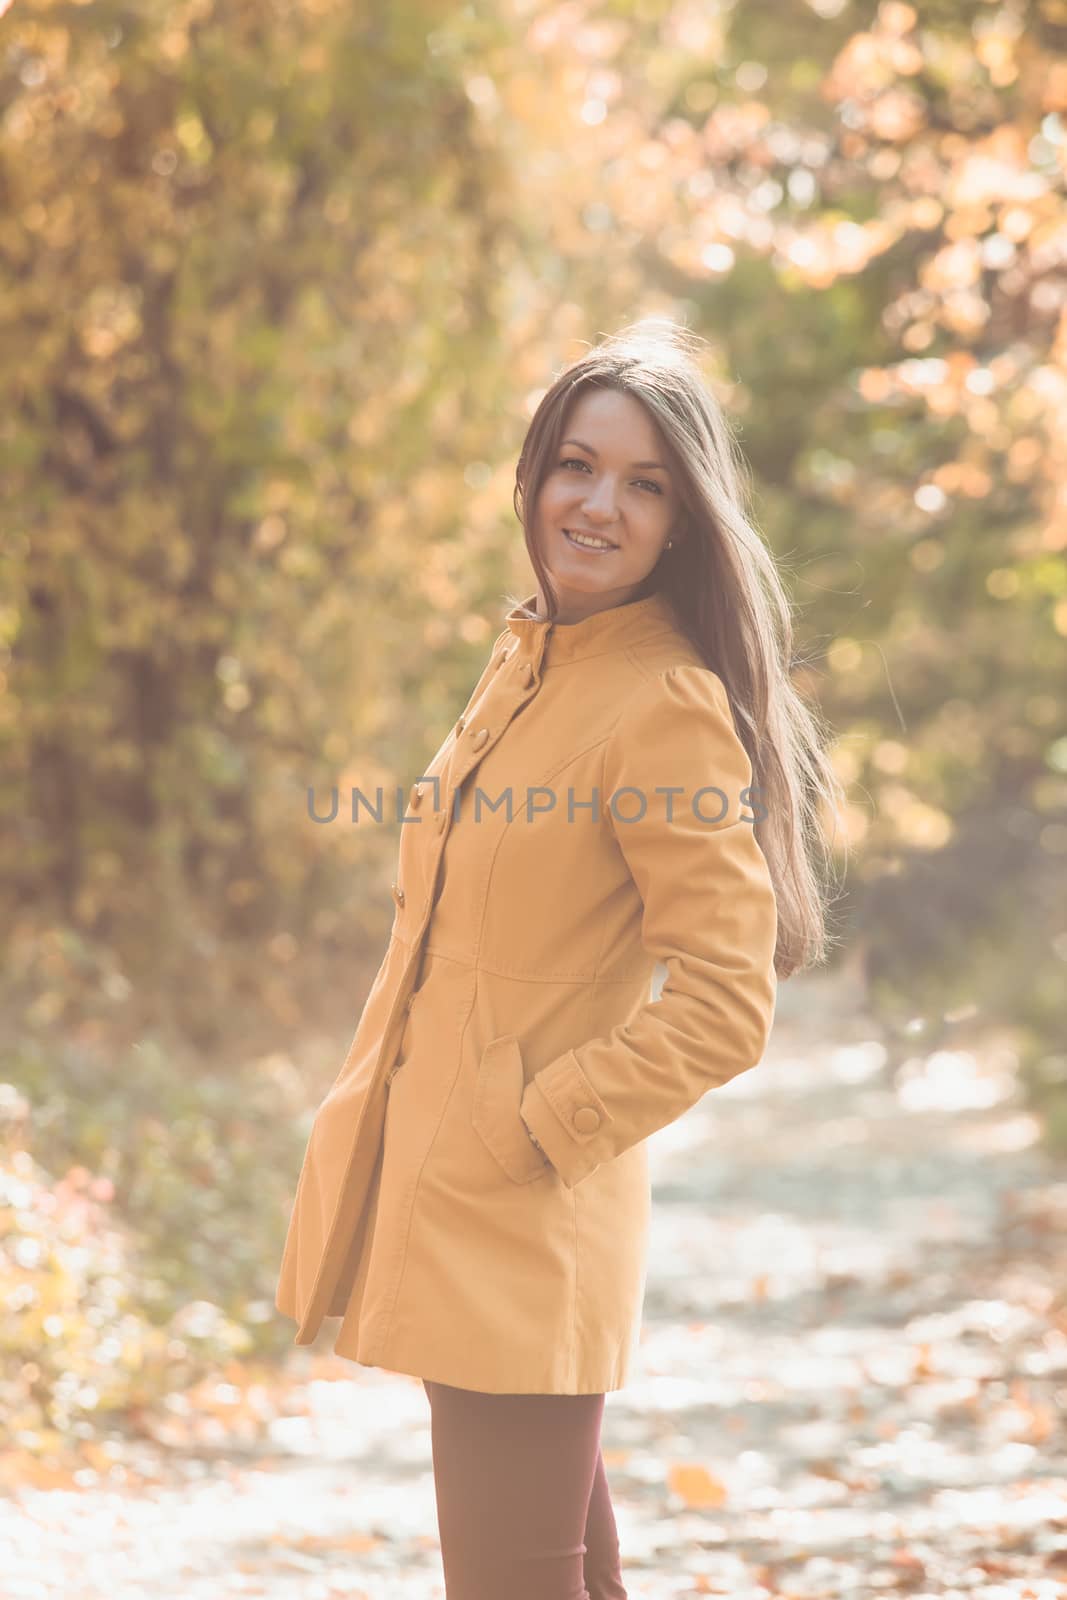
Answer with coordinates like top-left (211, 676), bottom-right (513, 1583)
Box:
top-left (275, 594), bottom-right (777, 1394)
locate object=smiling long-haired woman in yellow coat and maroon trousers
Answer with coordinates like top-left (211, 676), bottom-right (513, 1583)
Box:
top-left (277, 326), bottom-right (837, 1600)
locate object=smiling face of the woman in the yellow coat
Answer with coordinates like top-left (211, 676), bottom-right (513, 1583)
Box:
top-left (533, 389), bottom-right (681, 622)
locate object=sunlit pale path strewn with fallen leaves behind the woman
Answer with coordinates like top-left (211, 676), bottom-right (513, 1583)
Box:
top-left (0, 981), bottom-right (1067, 1600)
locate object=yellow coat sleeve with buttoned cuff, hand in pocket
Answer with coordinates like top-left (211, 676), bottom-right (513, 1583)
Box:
top-left (520, 666), bottom-right (777, 1189)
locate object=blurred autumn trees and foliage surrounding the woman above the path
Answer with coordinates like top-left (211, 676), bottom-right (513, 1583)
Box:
top-left (0, 0), bottom-right (1067, 1594)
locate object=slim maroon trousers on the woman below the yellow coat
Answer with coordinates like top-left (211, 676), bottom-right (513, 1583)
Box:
top-left (422, 1378), bottom-right (627, 1600)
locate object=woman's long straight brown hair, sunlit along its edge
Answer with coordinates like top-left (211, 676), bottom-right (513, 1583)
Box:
top-left (507, 317), bottom-right (848, 978)
